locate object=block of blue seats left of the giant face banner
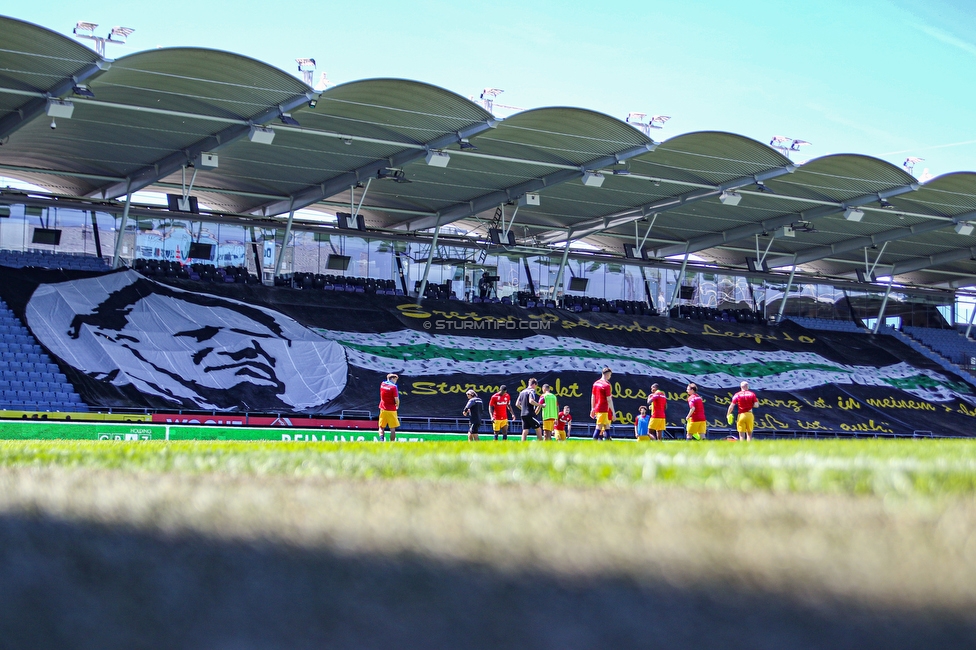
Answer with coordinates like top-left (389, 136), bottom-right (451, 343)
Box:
top-left (0, 300), bottom-right (88, 412)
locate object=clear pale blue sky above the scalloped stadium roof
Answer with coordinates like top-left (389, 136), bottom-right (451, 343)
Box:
top-left (8, 0), bottom-right (976, 175)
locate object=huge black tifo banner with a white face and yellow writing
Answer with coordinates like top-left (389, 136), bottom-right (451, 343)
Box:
top-left (0, 269), bottom-right (976, 433)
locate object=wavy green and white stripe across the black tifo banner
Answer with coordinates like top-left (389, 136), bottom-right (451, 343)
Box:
top-left (317, 330), bottom-right (976, 404)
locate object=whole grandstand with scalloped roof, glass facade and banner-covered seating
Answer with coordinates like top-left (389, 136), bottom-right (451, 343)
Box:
top-left (0, 17), bottom-right (976, 438)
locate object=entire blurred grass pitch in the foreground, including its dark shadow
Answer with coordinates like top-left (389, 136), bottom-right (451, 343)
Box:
top-left (0, 440), bottom-right (976, 648)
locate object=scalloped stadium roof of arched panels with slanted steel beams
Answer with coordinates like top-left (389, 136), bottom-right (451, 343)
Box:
top-left (0, 17), bottom-right (976, 288)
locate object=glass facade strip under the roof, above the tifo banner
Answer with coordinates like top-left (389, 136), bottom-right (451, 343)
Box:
top-left (0, 204), bottom-right (976, 327)
